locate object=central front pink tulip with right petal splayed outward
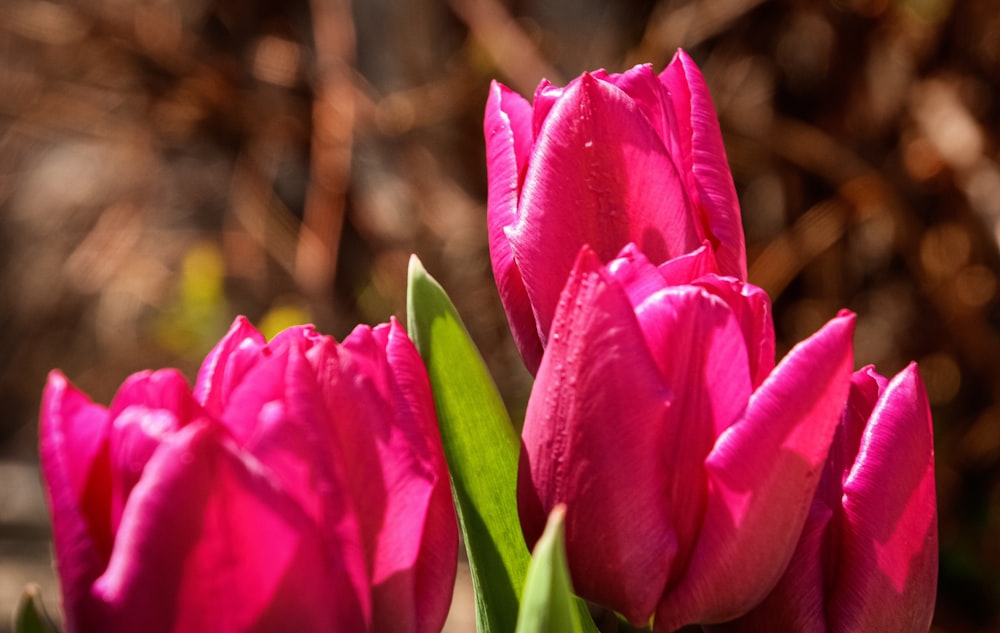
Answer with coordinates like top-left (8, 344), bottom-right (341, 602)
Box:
top-left (518, 246), bottom-right (854, 631)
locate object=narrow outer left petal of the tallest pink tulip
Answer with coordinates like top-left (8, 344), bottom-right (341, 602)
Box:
top-left (483, 82), bottom-right (542, 373)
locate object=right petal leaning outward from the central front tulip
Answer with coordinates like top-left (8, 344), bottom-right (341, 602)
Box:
top-left (654, 314), bottom-right (854, 631)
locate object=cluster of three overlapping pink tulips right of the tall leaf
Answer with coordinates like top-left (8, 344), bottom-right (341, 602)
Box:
top-left (485, 51), bottom-right (937, 631)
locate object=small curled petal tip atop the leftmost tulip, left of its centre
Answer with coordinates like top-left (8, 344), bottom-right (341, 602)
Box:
top-left (194, 316), bottom-right (267, 415)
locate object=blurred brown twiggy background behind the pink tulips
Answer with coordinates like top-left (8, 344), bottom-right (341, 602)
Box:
top-left (0, 0), bottom-right (1000, 633)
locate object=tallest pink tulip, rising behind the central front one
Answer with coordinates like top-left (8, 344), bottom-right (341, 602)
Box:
top-left (484, 51), bottom-right (746, 373)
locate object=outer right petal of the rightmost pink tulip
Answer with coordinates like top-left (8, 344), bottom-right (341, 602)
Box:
top-left (830, 364), bottom-right (938, 631)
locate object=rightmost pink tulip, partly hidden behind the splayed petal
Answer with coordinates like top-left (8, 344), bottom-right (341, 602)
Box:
top-left (710, 364), bottom-right (937, 633)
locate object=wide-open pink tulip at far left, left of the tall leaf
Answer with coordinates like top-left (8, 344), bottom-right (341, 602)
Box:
top-left (41, 318), bottom-right (458, 633)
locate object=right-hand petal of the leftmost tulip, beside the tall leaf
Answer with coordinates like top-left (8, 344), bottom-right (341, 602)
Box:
top-left (327, 320), bottom-right (458, 631)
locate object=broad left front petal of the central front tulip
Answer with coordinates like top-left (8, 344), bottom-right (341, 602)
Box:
top-left (518, 248), bottom-right (677, 624)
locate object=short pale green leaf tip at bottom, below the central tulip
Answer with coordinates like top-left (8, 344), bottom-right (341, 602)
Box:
top-left (517, 505), bottom-right (583, 633)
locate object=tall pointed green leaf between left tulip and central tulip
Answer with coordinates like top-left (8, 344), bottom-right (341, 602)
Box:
top-left (406, 256), bottom-right (531, 633)
